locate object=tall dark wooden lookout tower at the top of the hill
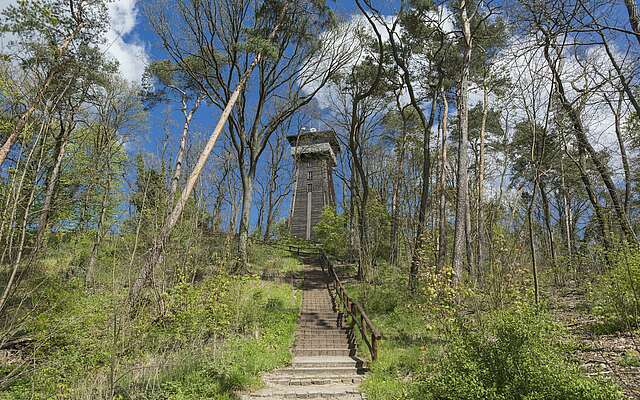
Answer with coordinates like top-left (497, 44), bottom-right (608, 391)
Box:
top-left (287, 129), bottom-right (340, 240)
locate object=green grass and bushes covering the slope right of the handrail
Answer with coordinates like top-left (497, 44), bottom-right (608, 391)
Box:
top-left (348, 269), bottom-right (632, 400)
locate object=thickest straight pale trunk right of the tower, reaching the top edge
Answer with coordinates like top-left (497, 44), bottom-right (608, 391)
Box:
top-left (453, 0), bottom-right (472, 283)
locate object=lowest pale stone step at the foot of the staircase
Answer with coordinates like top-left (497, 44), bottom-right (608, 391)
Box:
top-left (240, 384), bottom-right (362, 400)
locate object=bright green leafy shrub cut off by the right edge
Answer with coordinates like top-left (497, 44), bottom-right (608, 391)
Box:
top-left (589, 246), bottom-right (640, 331)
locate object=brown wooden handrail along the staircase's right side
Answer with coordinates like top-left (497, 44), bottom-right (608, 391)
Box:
top-left (320, 251), bottom-right (382, 361)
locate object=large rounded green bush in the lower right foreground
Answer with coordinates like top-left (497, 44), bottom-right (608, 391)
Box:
top-left (419, 306), bottom-right (623, 400)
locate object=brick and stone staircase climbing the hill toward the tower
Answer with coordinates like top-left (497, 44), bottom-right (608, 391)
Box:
top-left (240, 263), bottom-right (363, 400)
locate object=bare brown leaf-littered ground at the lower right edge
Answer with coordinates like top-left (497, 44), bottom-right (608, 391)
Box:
top-left (549, 285), bottom-right (640, 399)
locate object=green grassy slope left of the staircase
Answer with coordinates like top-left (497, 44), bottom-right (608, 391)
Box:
top-left (0, 239), bottom-right (301, 400)
